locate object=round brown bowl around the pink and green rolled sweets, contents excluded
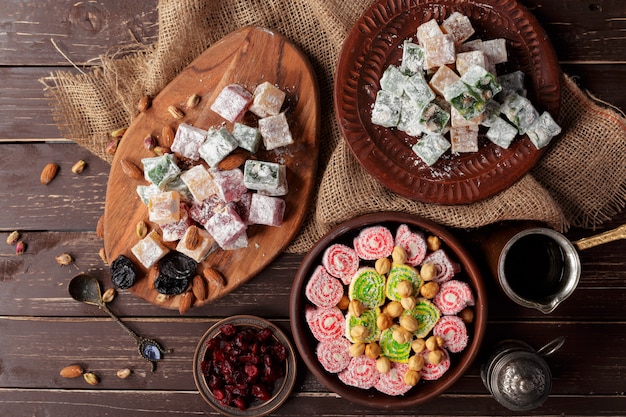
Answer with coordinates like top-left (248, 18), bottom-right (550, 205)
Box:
top-left (289, 212), bottom-right (487, 409)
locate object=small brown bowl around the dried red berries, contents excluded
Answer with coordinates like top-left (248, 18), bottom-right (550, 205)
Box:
top-left (193, 315), bottom-right (296, 417)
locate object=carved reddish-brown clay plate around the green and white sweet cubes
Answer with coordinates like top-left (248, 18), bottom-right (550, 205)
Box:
top-left (335, 0), bottom-right (561, 204)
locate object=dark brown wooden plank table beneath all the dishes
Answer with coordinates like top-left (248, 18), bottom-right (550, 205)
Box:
top-left (0, 0), bottom-right (626, 417)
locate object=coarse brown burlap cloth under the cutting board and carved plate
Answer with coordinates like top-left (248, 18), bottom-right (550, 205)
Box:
top-left (41, 0), bottom-right (626, 252)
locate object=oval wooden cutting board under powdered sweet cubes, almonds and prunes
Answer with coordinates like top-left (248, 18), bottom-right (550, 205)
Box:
top-left (104, 27), bottom-right (320, 309)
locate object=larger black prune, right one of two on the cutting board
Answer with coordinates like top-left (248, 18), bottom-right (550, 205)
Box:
top-left (154, 252), bottom-right (198, 295)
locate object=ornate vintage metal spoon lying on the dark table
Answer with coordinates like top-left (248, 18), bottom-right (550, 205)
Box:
top-left (68, 274), bottom-right (172, 372)
